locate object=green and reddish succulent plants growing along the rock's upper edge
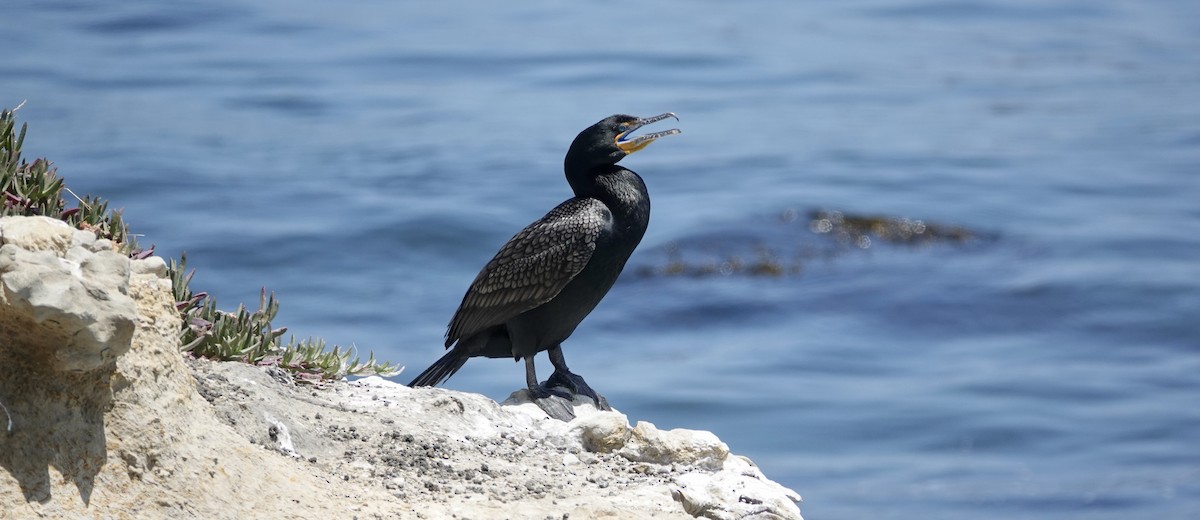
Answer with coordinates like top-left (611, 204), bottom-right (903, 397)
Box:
top-left (0, 107), bottom-right (401, 383)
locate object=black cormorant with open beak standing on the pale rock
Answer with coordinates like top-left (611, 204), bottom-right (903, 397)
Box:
top-left (409, 113), bottom-right (679, 420)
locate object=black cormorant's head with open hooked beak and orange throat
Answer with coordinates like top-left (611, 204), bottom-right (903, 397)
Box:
top-left (566, 112), bottom-right (680, 168)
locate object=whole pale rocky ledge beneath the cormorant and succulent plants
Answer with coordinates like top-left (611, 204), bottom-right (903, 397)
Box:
top-left (0, 212), bottom-right (800, 520)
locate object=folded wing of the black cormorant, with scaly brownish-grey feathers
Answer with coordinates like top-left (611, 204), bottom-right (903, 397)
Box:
top-left (446, 198), bottom-right (612, 348)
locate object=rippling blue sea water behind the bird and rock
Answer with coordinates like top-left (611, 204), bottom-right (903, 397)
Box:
top-left (0, 0), bottom-right (1200, 513)
